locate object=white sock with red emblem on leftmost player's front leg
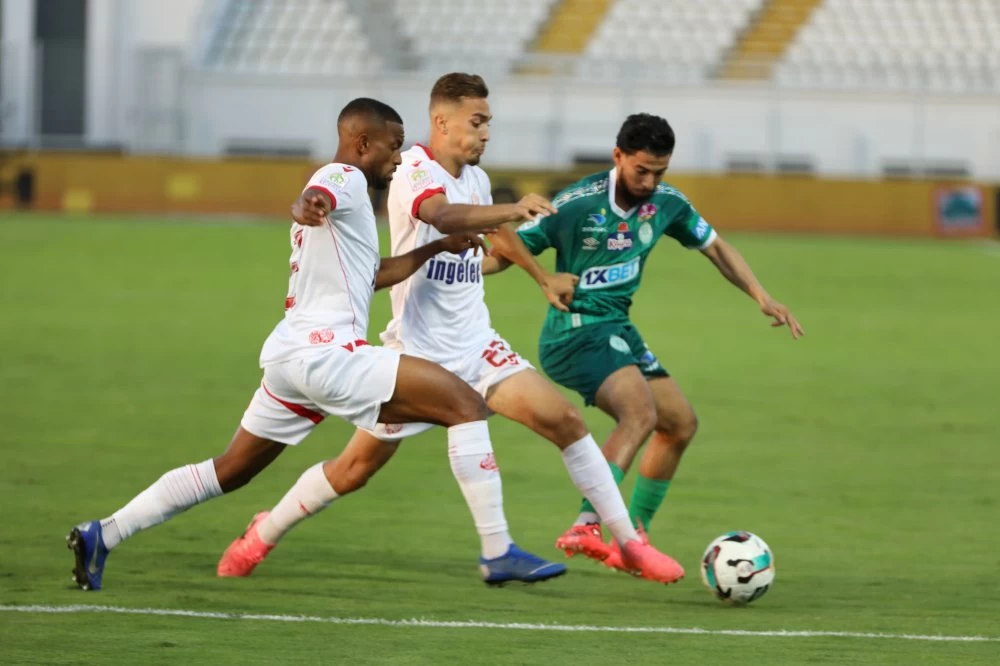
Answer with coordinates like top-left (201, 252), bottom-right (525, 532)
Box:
top-left (448, 421), bottom-right (514, 560)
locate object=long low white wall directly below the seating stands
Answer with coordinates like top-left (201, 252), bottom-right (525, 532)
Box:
top-left (180, 72), bottom-right (1000, 181)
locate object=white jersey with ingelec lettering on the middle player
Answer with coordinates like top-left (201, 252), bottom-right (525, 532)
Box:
top-left (381, 144), bottom-right (494, 363)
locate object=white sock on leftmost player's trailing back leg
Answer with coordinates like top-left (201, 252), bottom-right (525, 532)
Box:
top-left (101, 458), bottom-right (222, 550)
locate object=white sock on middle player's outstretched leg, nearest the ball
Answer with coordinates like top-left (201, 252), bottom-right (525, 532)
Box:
top-left (562, 434), bottom-right (639, 544)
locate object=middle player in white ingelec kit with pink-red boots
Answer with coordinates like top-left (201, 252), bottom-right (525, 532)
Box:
top-left (218, 73), bottom-right (684, 583)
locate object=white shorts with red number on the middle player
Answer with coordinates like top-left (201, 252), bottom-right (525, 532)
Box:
top-left (370, 335), bottom-right (535, 442)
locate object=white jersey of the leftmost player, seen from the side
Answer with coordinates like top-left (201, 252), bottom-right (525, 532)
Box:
top-left (260, 164), bottom-right (379, 367)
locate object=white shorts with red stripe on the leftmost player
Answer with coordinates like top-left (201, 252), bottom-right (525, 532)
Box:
top-left (240, 345), bottom-right (400, 444)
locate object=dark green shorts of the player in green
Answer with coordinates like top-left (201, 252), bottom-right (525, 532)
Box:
top-left (538, 321), bottom-right (670, 405)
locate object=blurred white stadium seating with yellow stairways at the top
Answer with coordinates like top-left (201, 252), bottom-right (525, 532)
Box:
top-left (195, 0), bottom-right (1000, 92)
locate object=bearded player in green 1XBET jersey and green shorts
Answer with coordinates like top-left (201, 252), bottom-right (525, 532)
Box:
top-left (497, 113), bottom-right (803, 568)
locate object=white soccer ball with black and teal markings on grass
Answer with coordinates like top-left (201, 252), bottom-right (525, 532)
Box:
top-left (701, 532), bottom-right (774, 606)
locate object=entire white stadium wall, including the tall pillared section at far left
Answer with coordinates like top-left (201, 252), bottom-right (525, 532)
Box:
top-left (0, 0), bottom-right (1000, 181)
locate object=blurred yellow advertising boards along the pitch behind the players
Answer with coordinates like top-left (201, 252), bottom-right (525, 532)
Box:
top-left (0, 153), bottom-right (1000, 236)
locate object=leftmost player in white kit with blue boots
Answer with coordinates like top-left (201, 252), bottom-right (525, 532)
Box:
top-left (67, 98), bottom-right (548, 590)
